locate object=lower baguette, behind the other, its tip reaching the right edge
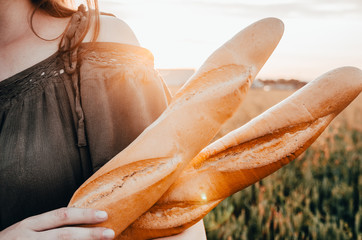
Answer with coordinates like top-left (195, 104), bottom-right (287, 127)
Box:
top-left (119, 67), bottom-right (362, 239)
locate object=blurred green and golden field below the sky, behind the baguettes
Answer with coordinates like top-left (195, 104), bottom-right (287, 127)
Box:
top-left (204, 91), bottom-right (362, 240)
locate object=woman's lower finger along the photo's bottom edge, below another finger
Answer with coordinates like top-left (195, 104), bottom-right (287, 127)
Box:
top-left (38, 227), bottom-right (114, 240)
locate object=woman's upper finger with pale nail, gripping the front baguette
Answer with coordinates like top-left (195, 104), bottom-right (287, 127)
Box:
top-left (23, 208), bottom-right (108, 231)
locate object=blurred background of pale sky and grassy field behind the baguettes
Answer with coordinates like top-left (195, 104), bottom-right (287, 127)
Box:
top-left (99, 0), bottom-right (362, 240)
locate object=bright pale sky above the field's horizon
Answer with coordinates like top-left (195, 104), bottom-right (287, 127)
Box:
top-left (99, 0), bottom-right (362, 81)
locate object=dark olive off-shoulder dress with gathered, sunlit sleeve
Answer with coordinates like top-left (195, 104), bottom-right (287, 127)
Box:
top-left (0, 27), bottom-right (170, 230)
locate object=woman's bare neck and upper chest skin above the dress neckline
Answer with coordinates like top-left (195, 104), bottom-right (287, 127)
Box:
top-left (0, 0), bottom-right (70, 81)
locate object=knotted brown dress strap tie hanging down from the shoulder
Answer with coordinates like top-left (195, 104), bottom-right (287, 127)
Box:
top-left (60, 4), bottom-right (88, 147)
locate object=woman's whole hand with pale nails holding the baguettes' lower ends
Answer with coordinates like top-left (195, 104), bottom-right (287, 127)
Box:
top-left (0, 208), bottom-right (114, 240)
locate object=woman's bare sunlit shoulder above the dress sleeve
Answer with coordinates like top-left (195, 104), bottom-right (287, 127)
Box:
top-left (84, 15), bottom-right (140, 46)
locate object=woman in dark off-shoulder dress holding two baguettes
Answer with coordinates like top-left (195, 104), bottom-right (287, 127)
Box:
top-left (0, 0), bottom-right (205, 240)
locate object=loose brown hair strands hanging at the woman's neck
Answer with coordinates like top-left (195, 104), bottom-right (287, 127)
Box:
top-left (30, 0), bottom-right (100, 49)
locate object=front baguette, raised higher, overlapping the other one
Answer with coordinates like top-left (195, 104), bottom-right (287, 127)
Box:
top-left (69, 18), bottom-right (283, 236)
